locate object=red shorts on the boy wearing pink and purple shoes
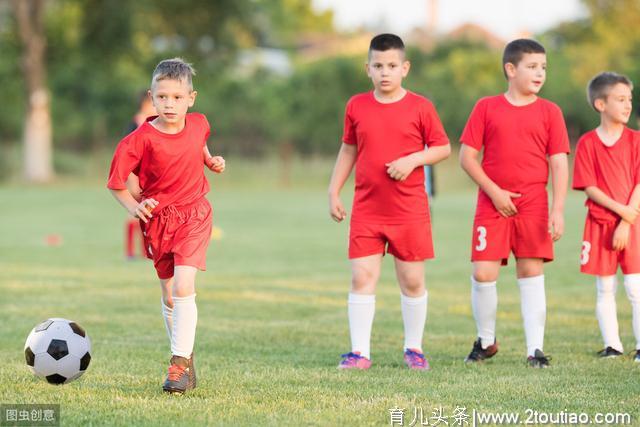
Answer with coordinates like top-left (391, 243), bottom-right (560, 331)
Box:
top-left (349, 220), bottom-right (434, 261)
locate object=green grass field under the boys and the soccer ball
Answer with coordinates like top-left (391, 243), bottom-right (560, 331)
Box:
top-left (0, 159), bottom-right (640, 426)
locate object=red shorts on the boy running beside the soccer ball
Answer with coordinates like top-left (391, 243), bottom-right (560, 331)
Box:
top-left (140, 197), bottom-right (213, 279)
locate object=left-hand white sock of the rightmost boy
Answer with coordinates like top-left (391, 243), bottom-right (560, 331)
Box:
top-left (596, 276), bottom-right (626, 352)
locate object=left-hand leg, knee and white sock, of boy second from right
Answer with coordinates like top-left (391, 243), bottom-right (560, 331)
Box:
top-left (471, 261), bottom-right (501, 349)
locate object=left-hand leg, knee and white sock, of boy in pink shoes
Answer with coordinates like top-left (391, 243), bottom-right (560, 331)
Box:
top-left (348, 254), bottom-right (382, 359)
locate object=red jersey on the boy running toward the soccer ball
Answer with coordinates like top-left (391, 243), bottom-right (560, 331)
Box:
top-left (107, 113), bottom-right (210, 210)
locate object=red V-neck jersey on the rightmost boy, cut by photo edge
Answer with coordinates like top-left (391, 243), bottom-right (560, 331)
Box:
top-left (573, 127), bottom-right (640, 223)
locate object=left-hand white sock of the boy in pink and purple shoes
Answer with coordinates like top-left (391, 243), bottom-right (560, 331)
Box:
top-left (349, 293), bottom-right (376, 359)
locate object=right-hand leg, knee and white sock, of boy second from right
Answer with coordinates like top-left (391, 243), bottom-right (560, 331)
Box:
top-left (516, 258), bottom-right (547, 357)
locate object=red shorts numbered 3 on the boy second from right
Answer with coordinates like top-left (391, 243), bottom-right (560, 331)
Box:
top-left (471, 214), bottom-right (553, 265)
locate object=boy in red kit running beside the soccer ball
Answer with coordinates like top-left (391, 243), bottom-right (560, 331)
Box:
top-left (107, 58), bottom-right (225, 393)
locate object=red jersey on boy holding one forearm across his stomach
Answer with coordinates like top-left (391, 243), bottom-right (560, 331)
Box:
top-left (342, 91), bottom-right (449, 224)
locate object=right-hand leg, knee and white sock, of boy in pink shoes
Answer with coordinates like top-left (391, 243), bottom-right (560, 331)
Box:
top-left (395, 258), bottom-right (428, 353)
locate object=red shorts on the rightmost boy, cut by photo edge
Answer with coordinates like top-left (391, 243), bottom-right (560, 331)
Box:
top-left (580, 215), bottom-right (640, 276)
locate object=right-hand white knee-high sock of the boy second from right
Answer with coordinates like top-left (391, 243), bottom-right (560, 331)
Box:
top-left (518, 274), bottom-right (547, 356)
